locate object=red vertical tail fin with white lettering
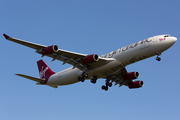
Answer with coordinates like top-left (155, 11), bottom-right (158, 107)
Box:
top-left (37, 60), bottom-right (55, 84)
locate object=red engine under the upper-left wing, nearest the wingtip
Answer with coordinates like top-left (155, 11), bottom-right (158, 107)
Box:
top-left (42, 45), bottom-right (58, 55)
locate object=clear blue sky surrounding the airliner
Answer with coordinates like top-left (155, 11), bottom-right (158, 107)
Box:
top-left (0, 0), bottom-right (180, 120)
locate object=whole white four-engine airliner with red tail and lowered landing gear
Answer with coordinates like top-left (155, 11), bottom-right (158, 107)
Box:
top-left (3, 34), bottom-right (177, 91)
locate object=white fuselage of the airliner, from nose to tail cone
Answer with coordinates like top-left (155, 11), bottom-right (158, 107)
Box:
top-left (47, 35), bottom-right (177, 86)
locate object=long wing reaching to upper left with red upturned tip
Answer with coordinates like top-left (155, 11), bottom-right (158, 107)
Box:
top-left (3, 34), bottom-right (113, 70)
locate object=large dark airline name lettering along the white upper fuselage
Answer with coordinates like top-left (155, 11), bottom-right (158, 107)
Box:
top-left (101, 37), bottom-right (153, 58)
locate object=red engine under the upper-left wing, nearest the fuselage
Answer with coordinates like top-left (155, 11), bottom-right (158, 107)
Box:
top-left (81, 54), bottom-right (99, 64)
